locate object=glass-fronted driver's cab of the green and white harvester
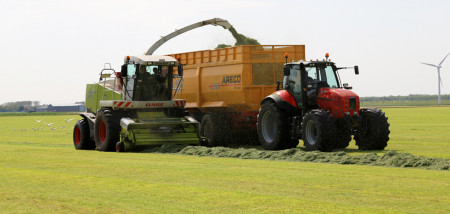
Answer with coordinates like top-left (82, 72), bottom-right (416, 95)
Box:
top-left (121, 55), bottom-right (182, 101)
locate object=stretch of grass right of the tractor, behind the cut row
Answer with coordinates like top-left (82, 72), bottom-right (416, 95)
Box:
top-left (345, 107), bottom-right (450, 159)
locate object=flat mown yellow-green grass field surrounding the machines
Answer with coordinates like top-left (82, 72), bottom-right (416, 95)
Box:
top-left (0, 108), bottom-right (450, 213)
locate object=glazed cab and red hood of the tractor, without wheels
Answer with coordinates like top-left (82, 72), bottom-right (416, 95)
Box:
top-left (282, 55), bottom-right (359, 118)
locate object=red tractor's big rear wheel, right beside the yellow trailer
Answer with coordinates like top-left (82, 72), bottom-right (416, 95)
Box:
top-left (257, 102), bottom-right (292, 150)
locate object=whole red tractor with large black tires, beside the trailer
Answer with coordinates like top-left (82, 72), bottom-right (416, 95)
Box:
top-left (257, 53), bottom-right (390, 152)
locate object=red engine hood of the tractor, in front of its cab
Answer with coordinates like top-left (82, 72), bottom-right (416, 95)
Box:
top-left (317, 88), bottom-right (359, 118)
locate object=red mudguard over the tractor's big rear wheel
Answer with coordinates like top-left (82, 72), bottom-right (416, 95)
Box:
top-left (261, 90), bottom-right (301, 115)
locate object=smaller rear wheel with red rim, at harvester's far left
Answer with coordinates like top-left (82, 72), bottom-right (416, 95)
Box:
top-left (73, 119), bottom-right (95, 150)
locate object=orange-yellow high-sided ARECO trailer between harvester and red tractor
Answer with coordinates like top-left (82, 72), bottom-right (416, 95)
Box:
top-left (169, 45), bottom-right (305, 146)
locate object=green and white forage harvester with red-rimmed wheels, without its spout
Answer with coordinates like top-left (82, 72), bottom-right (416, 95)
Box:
top-left (74, 55), bottom-right (201, 152)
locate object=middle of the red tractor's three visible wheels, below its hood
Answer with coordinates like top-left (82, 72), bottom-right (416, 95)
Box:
top-left (302, 109), bottom-right (336, 152)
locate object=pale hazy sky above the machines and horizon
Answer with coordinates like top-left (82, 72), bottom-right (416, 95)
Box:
top-left (0, 0), bottom-right (450, 104)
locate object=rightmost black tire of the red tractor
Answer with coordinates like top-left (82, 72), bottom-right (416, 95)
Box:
top-left (355, 108), bottom-right (391, 150)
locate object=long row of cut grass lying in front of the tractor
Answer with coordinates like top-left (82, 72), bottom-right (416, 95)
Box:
top-left (144, 145), bottom-right (450, 170)
